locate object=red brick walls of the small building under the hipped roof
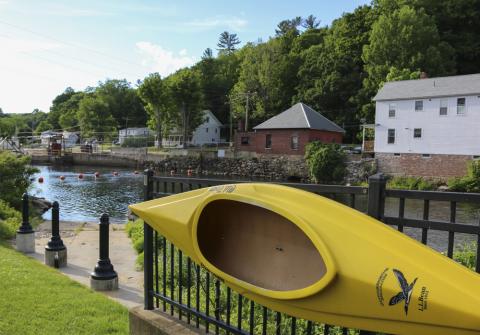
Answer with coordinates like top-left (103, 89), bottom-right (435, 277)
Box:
top-left (235, 129), bottom-right (343, 155)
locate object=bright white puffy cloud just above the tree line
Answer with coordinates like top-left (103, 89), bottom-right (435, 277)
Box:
top-left (136, 41), bottom-right (195, 76)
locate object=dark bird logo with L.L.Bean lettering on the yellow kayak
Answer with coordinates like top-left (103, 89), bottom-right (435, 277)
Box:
top-left (375, 268), bottom-right (429, 315)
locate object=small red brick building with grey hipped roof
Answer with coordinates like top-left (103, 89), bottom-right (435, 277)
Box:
top-left (235, 102), bottom-right (345, 155)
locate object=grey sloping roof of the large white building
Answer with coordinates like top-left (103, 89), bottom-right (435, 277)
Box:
top-left (373, 73), bottom-right (480, 101)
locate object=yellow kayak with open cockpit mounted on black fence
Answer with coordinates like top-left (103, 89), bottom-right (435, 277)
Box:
top-left (130, 184), bottom-right (480, 335)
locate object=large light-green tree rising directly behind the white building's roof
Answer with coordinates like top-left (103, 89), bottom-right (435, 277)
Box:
top-left (362, 5), bottom-right (455, 119)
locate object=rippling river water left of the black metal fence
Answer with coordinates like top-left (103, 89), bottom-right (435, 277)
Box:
top-left (31, 166), bottom-right (143, 222)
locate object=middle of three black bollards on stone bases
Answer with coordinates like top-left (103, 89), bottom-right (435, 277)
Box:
top-left (45, 201), bottom-right (67, 268)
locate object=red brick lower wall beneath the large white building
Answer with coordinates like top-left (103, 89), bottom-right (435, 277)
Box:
top-left (375, 153), bottom-right (472, 179)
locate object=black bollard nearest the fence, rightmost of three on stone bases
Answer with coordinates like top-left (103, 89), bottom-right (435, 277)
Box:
top-left (90, 214), bottom-right (118, 291)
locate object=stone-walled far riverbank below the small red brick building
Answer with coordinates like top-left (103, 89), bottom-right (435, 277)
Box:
top-left (31, 148), bottom-right (377, 183)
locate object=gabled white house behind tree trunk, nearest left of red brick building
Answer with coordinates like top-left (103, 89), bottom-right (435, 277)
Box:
top-left (162, 110), bottom-right (223, 147)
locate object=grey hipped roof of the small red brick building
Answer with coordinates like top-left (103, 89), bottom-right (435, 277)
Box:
top-left (253, 102), bottom-right (345, 133)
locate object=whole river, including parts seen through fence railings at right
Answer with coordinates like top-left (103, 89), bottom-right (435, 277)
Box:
top-left (31, 166), bottom-right (480, 251)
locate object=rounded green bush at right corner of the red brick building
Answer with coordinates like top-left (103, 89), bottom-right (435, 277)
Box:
top-left (305, 141), bottom-right (346, 183)
